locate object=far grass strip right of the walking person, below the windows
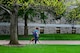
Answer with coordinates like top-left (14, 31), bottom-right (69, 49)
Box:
top-left (40, 34), bottom-right (80, 40)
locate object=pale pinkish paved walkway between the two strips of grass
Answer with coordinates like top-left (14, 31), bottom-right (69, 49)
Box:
top-left (0, 40), bottom-right (80, 45)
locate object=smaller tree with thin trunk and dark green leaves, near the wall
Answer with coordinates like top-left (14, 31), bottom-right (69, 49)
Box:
top-left (23, 7), bottom-right (46, 37)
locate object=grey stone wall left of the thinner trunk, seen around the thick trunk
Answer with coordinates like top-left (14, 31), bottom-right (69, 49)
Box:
top-left (0, 26), bottom-right (24, 35)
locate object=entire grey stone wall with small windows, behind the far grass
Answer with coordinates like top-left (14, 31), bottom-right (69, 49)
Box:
top-left (0, 26), bottom-right (80, 35)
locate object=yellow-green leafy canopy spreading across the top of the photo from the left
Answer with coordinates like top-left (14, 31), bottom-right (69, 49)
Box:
top-left (1, 0), bottom-right (66, 19)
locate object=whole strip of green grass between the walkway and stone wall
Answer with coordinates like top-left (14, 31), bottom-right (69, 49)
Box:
top-left (0, 34), bottom-right (80, 40)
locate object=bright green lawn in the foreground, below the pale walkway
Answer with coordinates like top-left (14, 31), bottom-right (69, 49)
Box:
top-left (0, 44), bottom-right (80, 53)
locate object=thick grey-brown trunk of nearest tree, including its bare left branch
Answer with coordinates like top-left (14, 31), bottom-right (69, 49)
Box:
top-left (0, 0), bottom-right (19, 45)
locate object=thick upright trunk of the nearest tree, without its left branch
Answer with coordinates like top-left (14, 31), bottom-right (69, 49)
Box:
top-left (9, 5), bottom-right (19, 45)
